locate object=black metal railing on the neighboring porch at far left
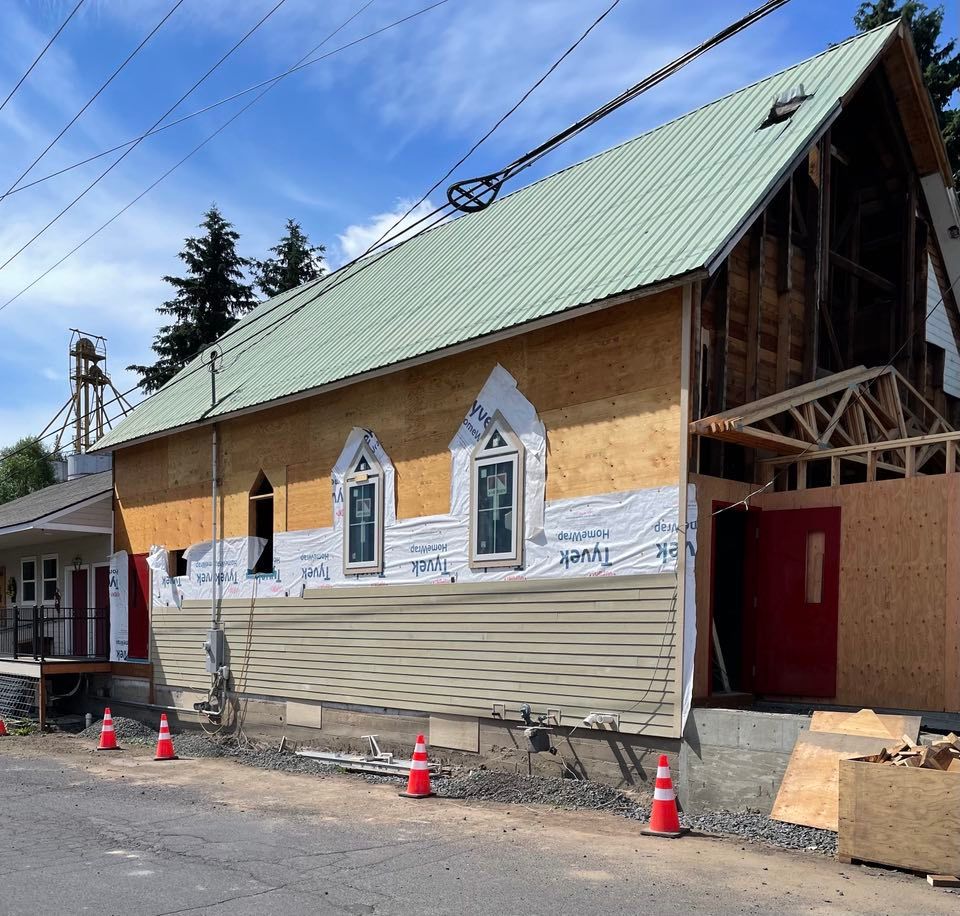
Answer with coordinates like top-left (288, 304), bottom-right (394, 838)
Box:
top-left (0, 607), bottom-right (110, 660)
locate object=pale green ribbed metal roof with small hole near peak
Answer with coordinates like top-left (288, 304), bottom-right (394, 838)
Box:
top-left (97, 22), bottom-right (899, 449)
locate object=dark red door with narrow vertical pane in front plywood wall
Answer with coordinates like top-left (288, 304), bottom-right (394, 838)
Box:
top-left (755, 508), bottom-right (840, 697)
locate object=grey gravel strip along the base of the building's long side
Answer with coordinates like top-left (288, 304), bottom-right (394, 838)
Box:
top-left (79, 716), bottom-right (837, 856)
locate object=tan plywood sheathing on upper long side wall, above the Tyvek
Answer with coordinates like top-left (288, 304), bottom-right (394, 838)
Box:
top-left (114, 289), bottom-right (681, 552)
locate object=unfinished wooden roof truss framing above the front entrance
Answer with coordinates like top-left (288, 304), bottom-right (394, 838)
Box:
top-left (690, 366), bottom-right (960, 487)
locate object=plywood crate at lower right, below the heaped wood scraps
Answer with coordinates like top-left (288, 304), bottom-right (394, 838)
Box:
top-left (837, 760), bottom-right (960, 875)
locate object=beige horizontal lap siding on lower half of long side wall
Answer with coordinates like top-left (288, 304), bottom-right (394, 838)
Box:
top-left (153, 575), bottom-right (677, 736)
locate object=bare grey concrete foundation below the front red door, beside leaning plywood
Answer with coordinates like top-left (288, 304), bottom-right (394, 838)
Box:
top-left (678, 709), bottom-right (810, 814)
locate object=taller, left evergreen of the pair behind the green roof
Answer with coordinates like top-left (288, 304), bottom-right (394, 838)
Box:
top-left (127, 205), bottom-right (256, 392)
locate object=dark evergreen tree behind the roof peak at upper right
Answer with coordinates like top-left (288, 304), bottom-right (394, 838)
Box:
top-left (853, 0), bottom-right (960, 182)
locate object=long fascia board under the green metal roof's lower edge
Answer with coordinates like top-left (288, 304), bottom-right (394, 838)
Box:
top-left (92, 269), bottom-right (709, 456)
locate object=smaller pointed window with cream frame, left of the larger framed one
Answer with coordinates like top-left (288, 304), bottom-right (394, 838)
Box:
top-left (343, 442), bottom-right (383, 575)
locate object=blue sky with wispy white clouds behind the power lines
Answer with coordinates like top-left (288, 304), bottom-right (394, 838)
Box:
top-left (0, 0), bottom-right (957, 445)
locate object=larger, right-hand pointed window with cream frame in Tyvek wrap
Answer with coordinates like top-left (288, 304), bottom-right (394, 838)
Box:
top-left (470, 411), bottom-right (523, 569)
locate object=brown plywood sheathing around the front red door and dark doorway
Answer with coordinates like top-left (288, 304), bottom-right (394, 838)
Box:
top-left (693, 474), bottom-right (960, 711)
